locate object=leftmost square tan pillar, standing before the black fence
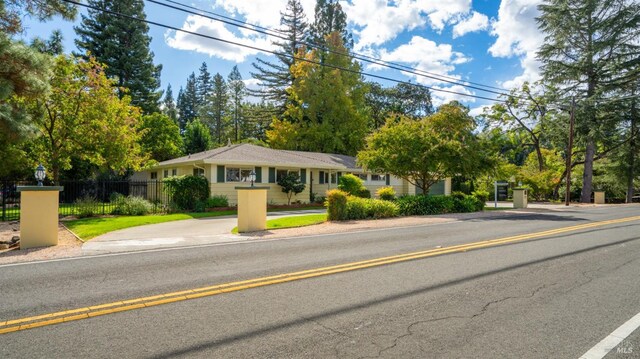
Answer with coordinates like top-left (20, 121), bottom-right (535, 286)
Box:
top-left (18, 186), bottom-right (63, 249)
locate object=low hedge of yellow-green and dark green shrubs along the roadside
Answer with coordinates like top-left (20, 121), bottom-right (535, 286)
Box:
top-left (325, 189), bottom-right (485, 221)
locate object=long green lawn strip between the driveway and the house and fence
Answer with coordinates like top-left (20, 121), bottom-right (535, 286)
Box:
top-left (63, 207), bottom-right (326, 241)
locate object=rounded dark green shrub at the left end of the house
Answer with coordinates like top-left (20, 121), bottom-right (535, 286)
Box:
top-left (163, 175), bottom-right (211, 210)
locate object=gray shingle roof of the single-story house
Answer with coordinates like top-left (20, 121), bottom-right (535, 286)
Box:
top-left (153, 143), bottom-right (357, 169)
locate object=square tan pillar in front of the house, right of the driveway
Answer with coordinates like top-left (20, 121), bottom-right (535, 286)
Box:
top-left (236, 186), bottom-right (269, 233)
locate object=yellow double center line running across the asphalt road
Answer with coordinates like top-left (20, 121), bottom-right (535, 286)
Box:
top-left (0, 216), bottom-right (640, 334)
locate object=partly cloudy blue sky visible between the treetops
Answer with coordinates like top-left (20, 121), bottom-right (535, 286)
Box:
top-left (17, 0), bottom-right (542, 113)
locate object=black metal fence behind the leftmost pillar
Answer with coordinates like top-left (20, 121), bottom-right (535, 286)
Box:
top-left (0, 180), bottom-right (171, 221)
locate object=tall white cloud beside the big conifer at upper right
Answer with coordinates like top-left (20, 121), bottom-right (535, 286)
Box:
top-left (489, 0), bottom-right (544, 88)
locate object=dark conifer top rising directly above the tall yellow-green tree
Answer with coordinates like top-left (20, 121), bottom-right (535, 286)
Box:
top-left (309, 0), bottom-right (353, 53)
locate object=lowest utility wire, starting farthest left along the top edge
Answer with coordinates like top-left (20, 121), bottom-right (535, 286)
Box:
top-left (62, 0), bottom-right (505, 102)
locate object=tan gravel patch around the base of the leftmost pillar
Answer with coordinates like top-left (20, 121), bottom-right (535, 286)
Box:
top-left (0, 222), bottom-right (82, 264)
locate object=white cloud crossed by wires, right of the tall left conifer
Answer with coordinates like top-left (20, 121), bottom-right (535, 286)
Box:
top-left (165, 15), bottom-right (274, 62)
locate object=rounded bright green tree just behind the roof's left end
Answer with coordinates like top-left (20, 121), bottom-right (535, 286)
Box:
top-left (138, 113), bottom-right (183, 162)
